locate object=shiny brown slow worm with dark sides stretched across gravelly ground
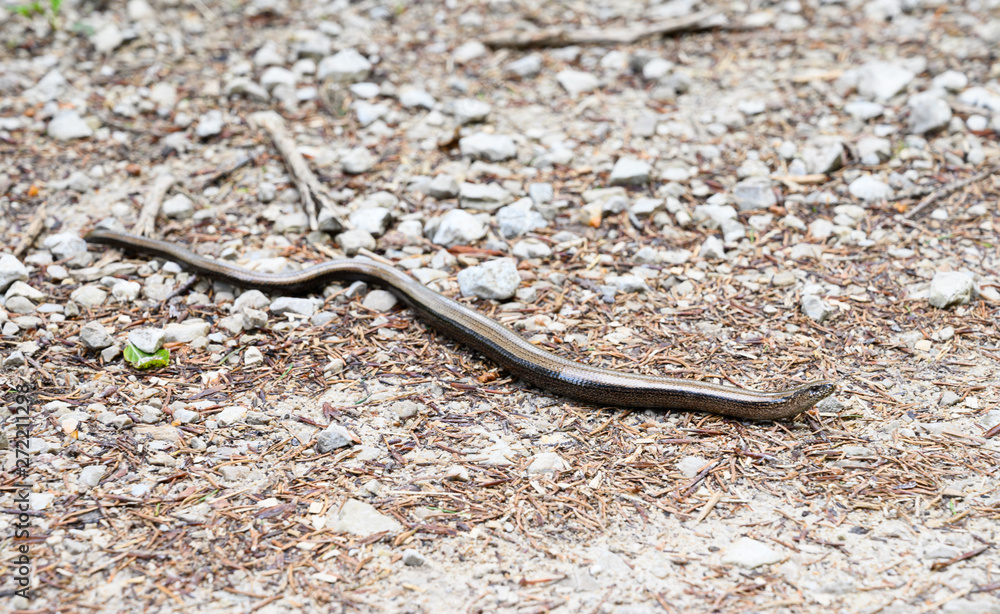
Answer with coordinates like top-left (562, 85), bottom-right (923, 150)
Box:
top-left (85, 229), bottom-right (836, 420)
